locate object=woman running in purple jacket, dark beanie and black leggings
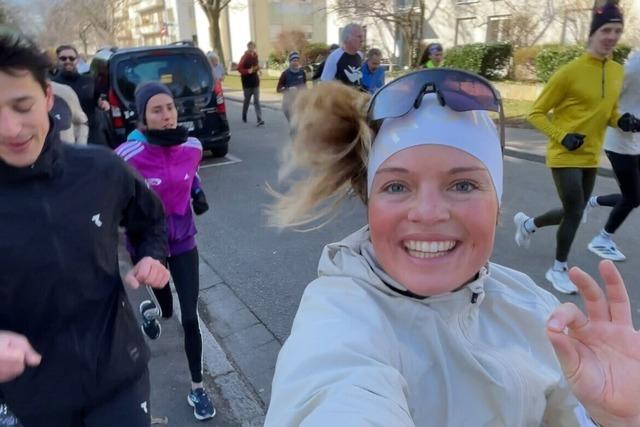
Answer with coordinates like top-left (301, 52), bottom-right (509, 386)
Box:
top-left (116, 82), bottom-right (216, 420)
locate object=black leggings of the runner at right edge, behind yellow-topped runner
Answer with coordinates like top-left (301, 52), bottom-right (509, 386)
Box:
top-left (598, 150), bottom-right (640, 234)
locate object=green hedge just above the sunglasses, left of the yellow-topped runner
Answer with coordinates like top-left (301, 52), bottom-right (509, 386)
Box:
top-left (445, 43), bottom-right (513, 80)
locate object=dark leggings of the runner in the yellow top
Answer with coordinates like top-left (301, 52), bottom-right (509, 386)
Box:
top-left (533, 168), bottom-right (598, 262)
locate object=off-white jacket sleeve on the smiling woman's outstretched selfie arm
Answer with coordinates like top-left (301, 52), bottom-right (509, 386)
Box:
top-left (265, 279), bottom-right (414, 427)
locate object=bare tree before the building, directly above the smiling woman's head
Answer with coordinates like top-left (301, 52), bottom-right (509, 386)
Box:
top-left (327, 0), bottom-right (428, 65)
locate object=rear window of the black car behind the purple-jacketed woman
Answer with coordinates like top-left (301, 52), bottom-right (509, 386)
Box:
top-left (116, 54), bottom-right (213, 102)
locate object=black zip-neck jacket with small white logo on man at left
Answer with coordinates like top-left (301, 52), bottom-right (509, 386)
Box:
top-left (0, 123), bottom-right (167, 418)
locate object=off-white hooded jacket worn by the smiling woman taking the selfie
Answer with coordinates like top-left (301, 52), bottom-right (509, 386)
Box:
top-left (265, 227), bottom-right (593, 427)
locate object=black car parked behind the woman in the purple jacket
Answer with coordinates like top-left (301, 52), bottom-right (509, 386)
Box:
top-left (90, 43), bottom-right (231, 157)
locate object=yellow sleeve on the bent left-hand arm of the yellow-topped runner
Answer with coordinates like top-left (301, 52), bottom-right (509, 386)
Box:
top-left (527, 68), bottom-right (571, 142)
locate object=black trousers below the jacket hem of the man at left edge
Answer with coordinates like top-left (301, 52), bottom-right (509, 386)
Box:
top-left (20, 372), bottom-right (151, 427)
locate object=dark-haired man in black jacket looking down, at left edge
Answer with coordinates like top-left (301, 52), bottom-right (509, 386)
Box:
top-left (0, 31), bottom-right (169, 427)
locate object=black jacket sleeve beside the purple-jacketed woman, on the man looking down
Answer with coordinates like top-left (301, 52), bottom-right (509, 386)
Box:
top-left (119, 160), bottom-right (168, 262)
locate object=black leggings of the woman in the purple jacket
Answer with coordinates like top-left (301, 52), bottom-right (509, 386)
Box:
top-left (138, 247), bottom-right (202, 383)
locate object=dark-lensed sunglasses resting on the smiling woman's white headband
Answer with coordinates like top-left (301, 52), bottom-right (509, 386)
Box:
top-left (367, 68), bottom-right (505, 149)
